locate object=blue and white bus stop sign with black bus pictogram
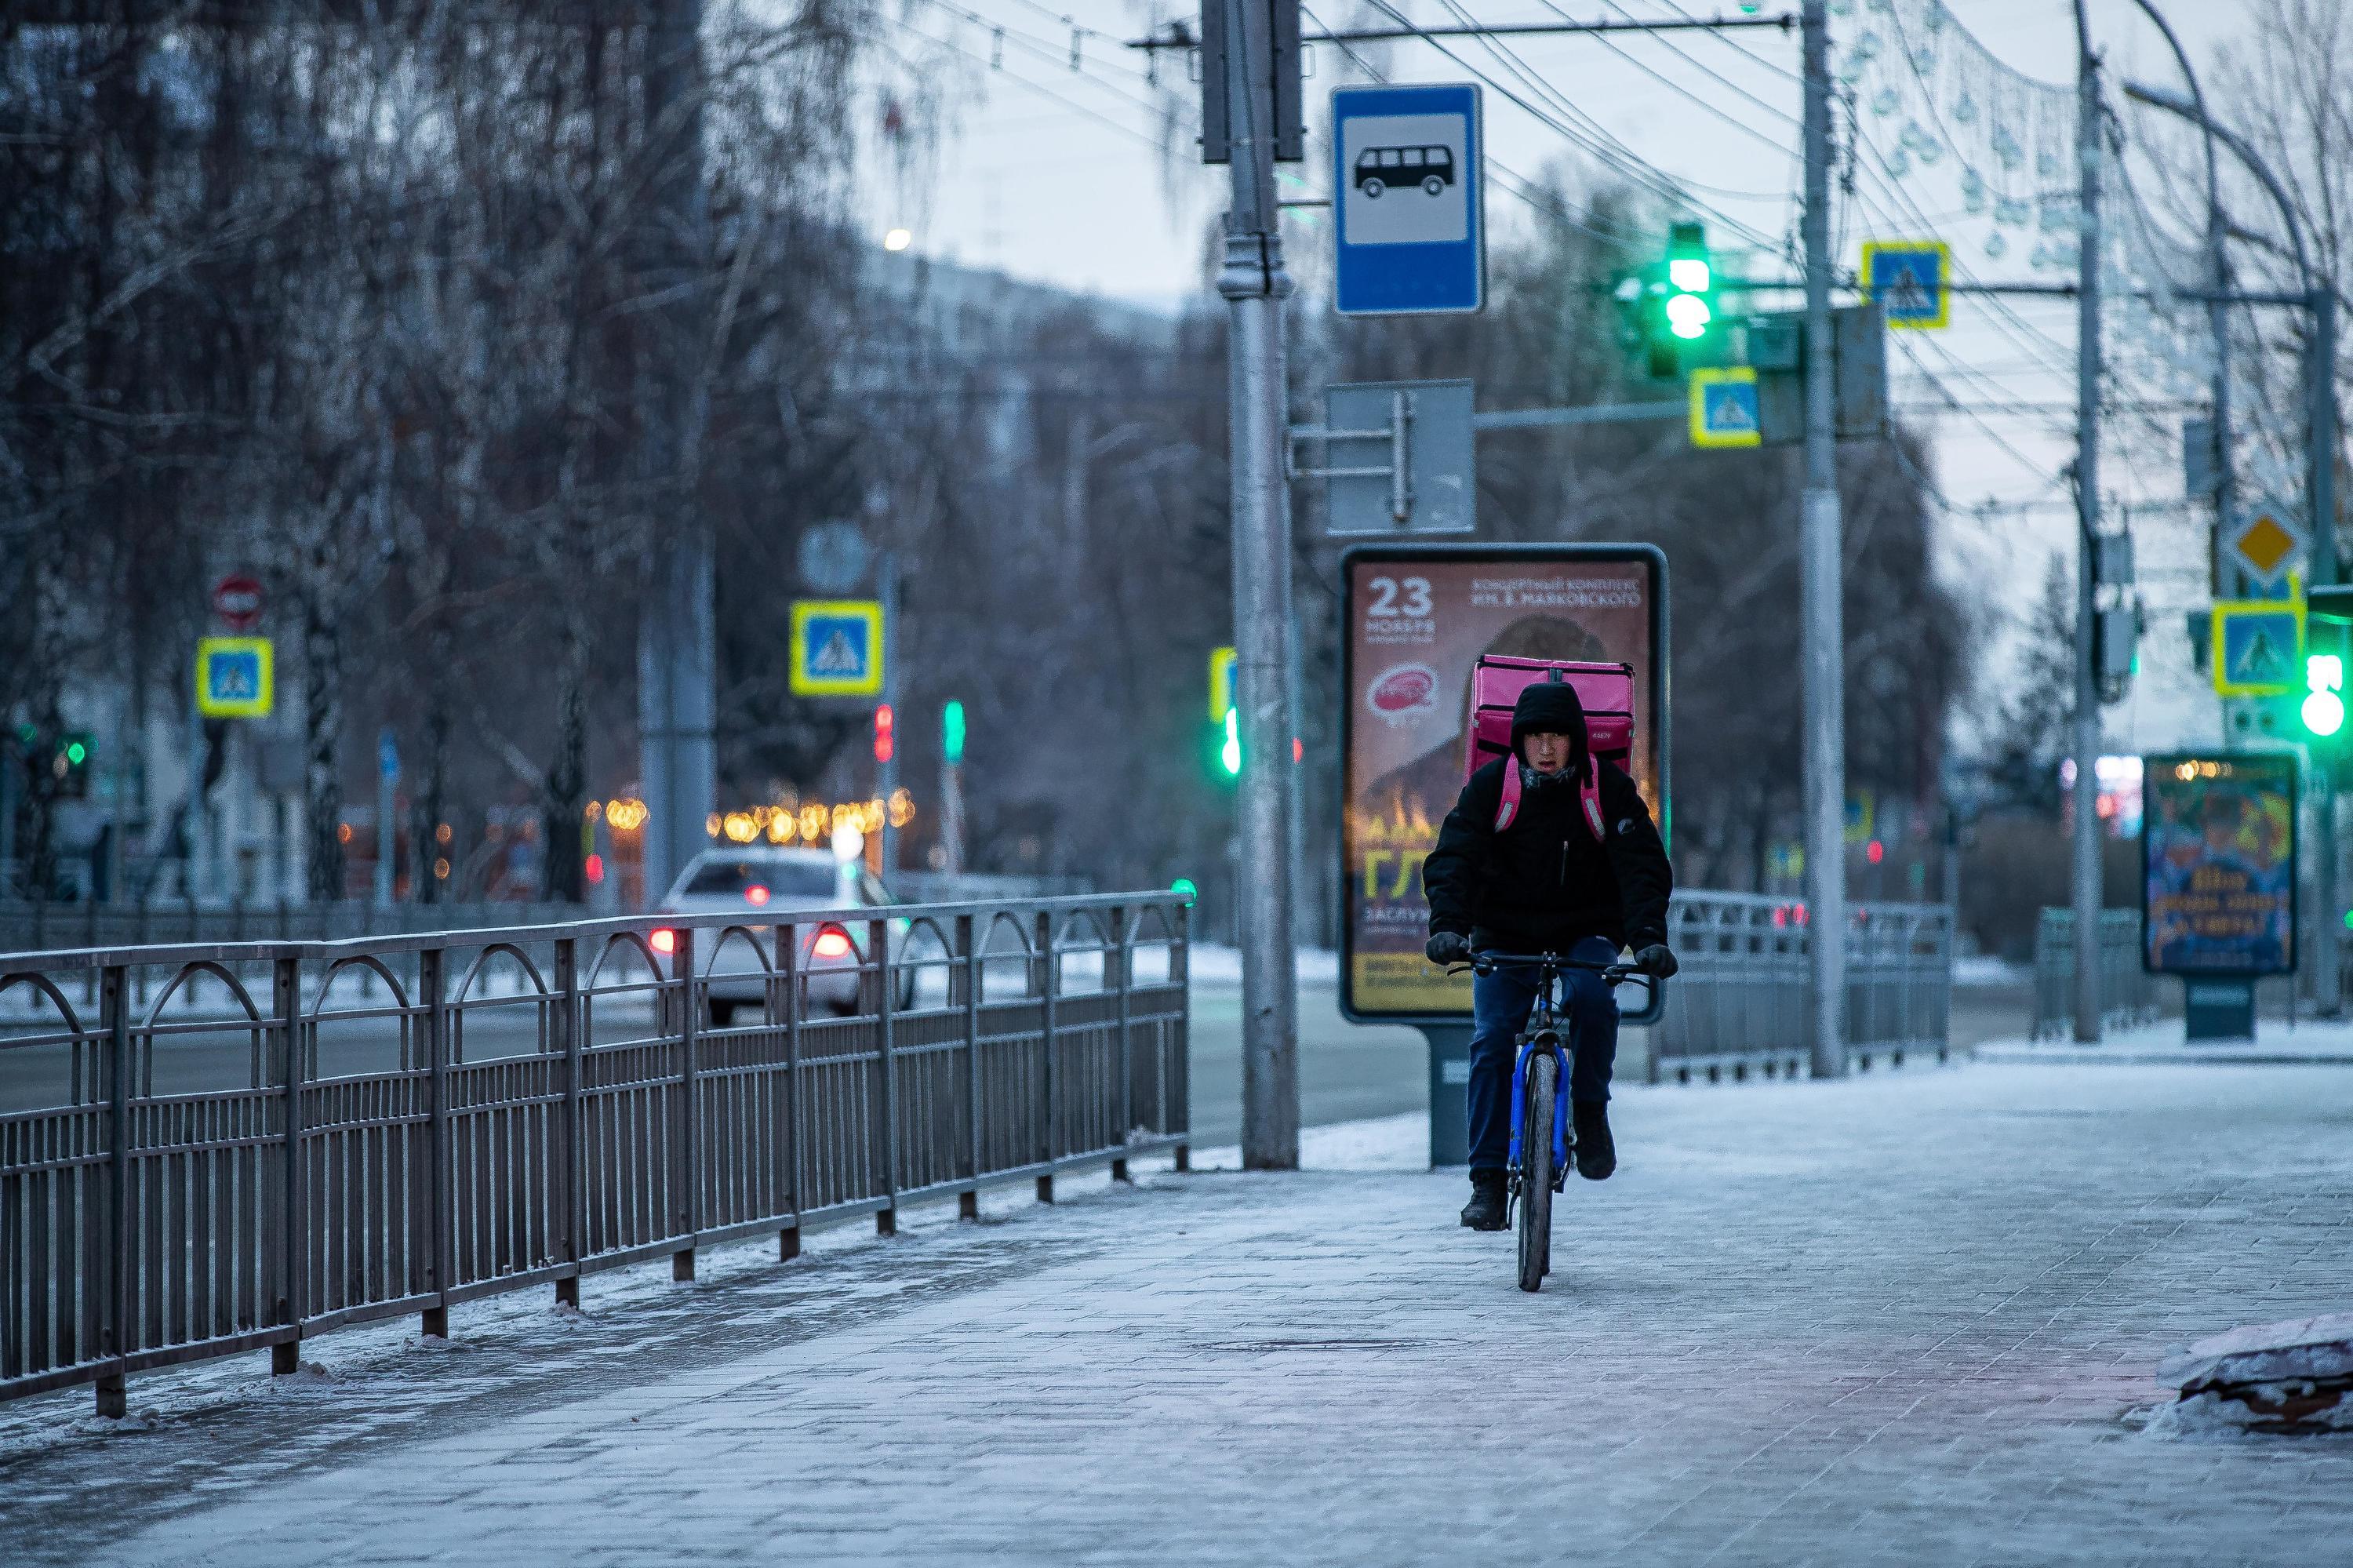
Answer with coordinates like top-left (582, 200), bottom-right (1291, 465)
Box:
top-left (1332, 82), bottom-right (1487, 315)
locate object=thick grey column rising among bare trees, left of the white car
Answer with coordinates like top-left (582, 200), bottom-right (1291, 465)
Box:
top-left (638, 0), bottom-right (718, 902)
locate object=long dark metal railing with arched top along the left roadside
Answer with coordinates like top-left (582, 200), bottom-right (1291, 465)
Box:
top-left (0, 893), bottom-right (1188, 1413)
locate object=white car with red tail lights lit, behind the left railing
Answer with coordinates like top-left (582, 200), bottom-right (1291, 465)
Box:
top-left (654, 848), bottom-right (915, 1029)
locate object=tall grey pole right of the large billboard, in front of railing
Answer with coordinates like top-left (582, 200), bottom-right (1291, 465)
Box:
top-left (1798, 0), bottom-right (1847, 1079)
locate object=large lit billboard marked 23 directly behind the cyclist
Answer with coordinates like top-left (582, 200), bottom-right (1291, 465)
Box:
top-left (1339, 544), bottom-right (1671, 1024)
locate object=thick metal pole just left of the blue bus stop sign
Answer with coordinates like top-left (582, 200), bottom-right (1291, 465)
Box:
top-left (1214, 0), bottom-right (1299, 1170)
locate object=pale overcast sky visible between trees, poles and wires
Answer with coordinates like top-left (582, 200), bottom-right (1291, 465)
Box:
top-left (864, 0), bottom-right (2247, 746)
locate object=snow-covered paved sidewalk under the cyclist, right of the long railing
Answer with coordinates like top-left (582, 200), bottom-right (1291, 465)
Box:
top-left (0, 1064), bottom-right (2353, 1568)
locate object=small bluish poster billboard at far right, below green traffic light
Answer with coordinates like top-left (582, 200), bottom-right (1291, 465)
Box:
top-left (2141, 751), bottom-right (2297, 977)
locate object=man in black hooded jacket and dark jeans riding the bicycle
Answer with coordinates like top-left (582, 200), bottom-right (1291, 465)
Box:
top-left (1421, 680), bottom-right (1675, 1231)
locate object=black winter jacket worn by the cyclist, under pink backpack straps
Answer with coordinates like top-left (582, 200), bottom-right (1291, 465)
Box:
top-left (1421, 758), bottom-right (1675, 954)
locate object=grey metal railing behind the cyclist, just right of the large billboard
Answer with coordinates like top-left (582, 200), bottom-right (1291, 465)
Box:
top-left (1649, 893), bottom-right (1953, 1081)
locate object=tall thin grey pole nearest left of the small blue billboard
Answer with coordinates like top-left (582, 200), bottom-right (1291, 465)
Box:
top-left (2075, 0), bottom-right (2101, 1046)
